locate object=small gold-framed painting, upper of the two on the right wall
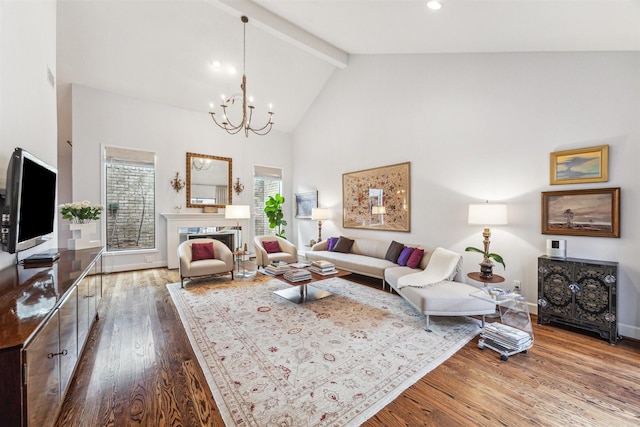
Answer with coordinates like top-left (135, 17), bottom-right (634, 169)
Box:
top-left (549, 145), bottom-right (609, 185)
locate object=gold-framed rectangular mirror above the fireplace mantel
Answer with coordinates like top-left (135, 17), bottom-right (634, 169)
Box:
top-left (186, 153), bottom-right (231, 208)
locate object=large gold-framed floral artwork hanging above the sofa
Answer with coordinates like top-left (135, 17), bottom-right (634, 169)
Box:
top-left (342, 162), bottom-right (411, 232)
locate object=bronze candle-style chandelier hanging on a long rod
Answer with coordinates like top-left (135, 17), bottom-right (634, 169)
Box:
top-left (209, 16), bottom-right (274, 137)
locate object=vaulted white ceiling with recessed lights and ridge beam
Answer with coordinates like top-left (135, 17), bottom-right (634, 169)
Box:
top-left (57, 0), bottom-right (640, 132)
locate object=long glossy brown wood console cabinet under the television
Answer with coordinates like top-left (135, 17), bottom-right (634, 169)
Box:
top-left (0, 248), bottom-right (103, 427)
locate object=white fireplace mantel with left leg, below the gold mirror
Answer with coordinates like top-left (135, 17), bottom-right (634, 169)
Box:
top-left (160, 213), bottom-right (249, 268)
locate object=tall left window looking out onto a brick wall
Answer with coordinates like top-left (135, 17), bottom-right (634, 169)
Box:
top-left (104, 147), bottom-right (156, 252)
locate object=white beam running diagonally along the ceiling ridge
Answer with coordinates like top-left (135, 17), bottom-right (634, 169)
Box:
top-left (207, 0), bottom-right (349, 68)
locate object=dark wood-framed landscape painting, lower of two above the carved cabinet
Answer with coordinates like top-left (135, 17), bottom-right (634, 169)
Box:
top-left (542, 187), bottom-right (620, 237)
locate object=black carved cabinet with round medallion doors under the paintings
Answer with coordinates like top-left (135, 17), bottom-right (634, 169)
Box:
top-left (538, 256), bottom-right (618, 345)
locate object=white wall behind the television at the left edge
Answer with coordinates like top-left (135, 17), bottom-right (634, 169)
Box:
top-left (0, 0), bottom-right (58, 268)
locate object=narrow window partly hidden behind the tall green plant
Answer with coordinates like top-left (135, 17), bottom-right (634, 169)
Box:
top-left (253, 166), bottom-right (282, 236)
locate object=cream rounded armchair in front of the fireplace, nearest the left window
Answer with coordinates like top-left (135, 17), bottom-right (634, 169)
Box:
top-left (178, 239), bottom-right (234, 287)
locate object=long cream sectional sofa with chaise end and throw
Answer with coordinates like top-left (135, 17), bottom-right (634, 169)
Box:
top-left (306, 238), bottom-right (496, 331)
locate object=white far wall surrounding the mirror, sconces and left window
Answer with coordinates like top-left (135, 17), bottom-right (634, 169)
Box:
top-left (71, 85), bottom-right (292, 271)
